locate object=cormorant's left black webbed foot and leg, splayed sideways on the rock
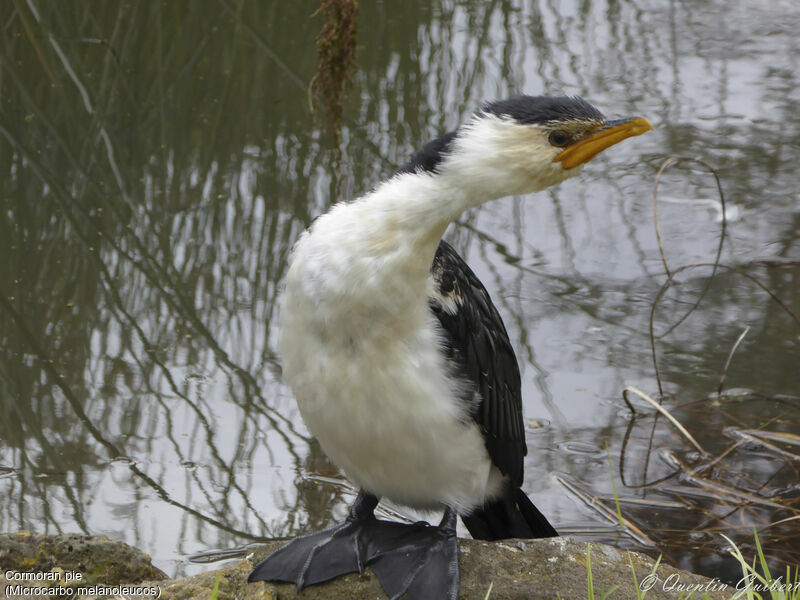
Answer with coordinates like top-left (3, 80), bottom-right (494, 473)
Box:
top-left (247, 489), bottom-right (379, 591)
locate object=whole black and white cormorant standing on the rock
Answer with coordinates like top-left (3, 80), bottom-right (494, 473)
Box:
top-left (249, 95), bottom-right (652, 600)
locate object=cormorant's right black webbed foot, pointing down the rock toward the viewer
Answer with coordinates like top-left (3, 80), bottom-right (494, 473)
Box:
top-left (367, 508), bottom-right (460, 600)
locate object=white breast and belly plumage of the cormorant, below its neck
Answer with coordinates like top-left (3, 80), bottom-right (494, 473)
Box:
top-left (280, 178), bottom-right (499, 511)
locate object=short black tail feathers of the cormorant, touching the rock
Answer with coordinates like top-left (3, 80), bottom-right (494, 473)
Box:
top-left (461, 485), bottom-right (558, 540)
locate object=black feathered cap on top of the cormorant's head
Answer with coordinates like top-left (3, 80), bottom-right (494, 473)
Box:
top-left (482, 96), bottom-right (605, 125)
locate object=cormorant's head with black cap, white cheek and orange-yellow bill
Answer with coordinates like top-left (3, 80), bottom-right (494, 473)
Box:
top-left (416, 96), bottom-right (653, 199)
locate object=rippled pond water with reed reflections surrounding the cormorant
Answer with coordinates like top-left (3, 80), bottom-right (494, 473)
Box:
top-left (0, 0), bottom-right (800, 576)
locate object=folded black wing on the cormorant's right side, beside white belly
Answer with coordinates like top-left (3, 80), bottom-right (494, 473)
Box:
top-left (429, 240), bottom-right (528, 487)
